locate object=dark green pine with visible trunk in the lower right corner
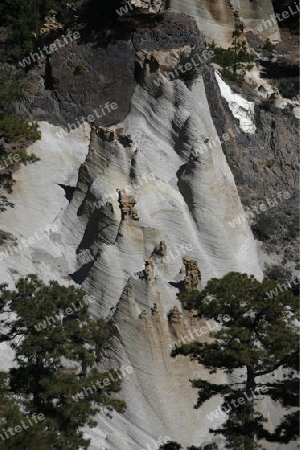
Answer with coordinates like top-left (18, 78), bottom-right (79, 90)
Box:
top-left (172, 272), bottom-right (299, 450)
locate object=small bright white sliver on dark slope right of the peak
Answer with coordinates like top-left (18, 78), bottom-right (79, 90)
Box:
top-left (216, 73), bottom-right (256, 134)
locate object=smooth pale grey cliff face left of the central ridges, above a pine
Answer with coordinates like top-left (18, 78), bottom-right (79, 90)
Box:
top-left (0, 122), bottom-right (89, 287)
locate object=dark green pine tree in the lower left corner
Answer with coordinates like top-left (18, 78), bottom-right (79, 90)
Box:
top-left (0, 275), bottom-right (125, 450)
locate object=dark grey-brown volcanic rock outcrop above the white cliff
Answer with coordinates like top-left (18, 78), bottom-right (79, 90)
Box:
top-left (17, 13), bottom-right (204, 126)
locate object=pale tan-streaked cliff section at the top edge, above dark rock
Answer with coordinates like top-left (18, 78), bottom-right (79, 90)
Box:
top-left (170, 0), bottom-right (280, 47)
